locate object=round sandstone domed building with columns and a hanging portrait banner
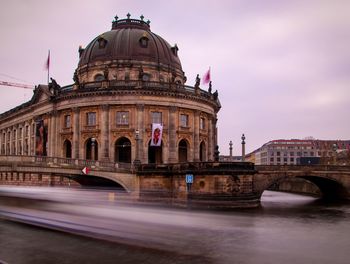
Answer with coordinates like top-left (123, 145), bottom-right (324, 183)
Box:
top-left (0, 14), bottom-right (220, 164)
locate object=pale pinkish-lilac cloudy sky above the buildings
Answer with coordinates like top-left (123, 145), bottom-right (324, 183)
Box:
top-left (0, 0), bottom-right (350, 155)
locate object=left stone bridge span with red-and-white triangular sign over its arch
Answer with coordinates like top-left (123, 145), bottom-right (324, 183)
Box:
top-left (0, 156), bottom-right (137, 192)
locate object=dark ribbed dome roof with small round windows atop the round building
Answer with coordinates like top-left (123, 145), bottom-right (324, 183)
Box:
top-left (79, 14), bottom-right (182, 70)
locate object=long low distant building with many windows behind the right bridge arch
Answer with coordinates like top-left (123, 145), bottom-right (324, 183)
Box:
top-left (250, 138), bottom-right (350, 165)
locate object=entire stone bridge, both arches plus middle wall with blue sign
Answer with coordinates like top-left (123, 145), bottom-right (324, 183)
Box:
top-left (0, 156), bottom-right (350, 207)
